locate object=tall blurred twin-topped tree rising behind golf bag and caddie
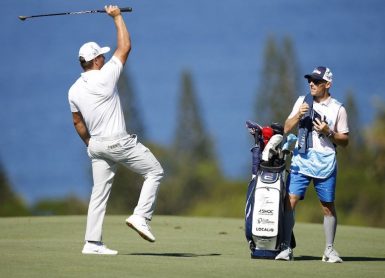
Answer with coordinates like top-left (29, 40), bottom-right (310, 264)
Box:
top-left (254, 37), bottom-right (299, 125)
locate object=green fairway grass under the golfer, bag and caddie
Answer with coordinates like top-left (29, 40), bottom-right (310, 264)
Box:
top-left (0, 216), bottom-right (385, 278)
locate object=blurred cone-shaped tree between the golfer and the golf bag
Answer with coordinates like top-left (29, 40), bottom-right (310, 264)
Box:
top-left (155, 71), bottom-right (223, 214)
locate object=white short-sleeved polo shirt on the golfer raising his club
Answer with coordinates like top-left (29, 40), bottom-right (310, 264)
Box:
top-left (68, 56), bottom-right (126, 137)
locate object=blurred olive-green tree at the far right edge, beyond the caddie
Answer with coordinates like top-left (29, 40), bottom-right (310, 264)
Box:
top-left (337, 100), bottom-right (385, 227)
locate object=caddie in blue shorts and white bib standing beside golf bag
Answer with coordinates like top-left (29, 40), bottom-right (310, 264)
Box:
top-left (275, 67), bottom-right (349, 263)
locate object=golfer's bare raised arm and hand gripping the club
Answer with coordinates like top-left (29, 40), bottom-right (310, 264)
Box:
top-left (104, 5), bottom-right (131, 65)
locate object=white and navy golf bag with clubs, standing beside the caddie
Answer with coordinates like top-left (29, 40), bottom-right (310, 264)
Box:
top-left (245, 122), bottom-right (295, 259)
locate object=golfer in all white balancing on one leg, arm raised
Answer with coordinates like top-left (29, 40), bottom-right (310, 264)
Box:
top-left (68, 5), bottom-right (163, 255)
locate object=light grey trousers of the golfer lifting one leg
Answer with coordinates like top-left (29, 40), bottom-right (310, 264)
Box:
top-left (85, 134), bottom-right (163, 241)
